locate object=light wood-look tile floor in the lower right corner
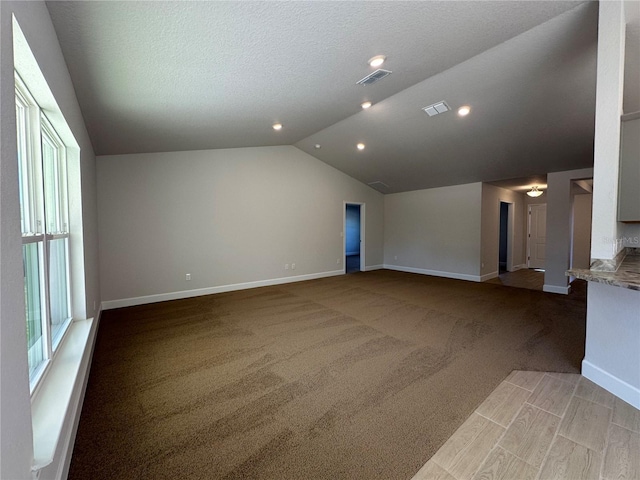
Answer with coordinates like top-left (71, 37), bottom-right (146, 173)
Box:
top-left (413, 371), bottom-right (640, 480)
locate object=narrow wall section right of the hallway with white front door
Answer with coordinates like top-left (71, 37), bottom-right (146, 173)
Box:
top-left (543, 168), bottom-right (595, 294)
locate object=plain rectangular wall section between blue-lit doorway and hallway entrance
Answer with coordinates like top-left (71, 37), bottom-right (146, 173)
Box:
top-left (384, 183), bottom-right (482, 281)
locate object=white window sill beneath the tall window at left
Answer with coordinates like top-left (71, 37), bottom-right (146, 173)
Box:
top-left (31, 318), bottom-right (97, 471)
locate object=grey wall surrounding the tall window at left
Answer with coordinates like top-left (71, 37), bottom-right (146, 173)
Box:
top-left (0, 1), bottom-right (100, 479)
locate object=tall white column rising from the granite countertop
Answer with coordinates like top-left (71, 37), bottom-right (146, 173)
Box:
top-left (591, 1), bottom-right (626, 259)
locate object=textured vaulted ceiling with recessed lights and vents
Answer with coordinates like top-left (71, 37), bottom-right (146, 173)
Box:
top-left (47, 1), bottom-right (634, 192)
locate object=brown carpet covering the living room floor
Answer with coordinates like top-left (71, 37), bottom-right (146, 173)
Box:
top-left (69, 270), bottom-right (586, 480)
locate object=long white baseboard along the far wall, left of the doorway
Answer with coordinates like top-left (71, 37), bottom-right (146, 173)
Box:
top-left (102, 269), bottom-right (344, 310)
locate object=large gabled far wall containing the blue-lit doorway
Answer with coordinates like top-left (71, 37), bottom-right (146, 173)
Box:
top-left (97, 146), bottom-right (383, 307)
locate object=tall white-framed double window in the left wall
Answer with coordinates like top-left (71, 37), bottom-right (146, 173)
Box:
top-left (16, 74), bottom-right (71, 391)
